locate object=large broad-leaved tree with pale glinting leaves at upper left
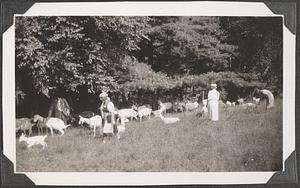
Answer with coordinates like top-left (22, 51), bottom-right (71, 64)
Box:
top-left (16, 16), bottom-right (147, 114)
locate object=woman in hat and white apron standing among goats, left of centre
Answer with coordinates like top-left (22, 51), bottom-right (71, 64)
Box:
top-left (99, 92), bottom-right (116, 142)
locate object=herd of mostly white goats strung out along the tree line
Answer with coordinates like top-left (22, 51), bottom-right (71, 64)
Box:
top-left (16, 97), bottom-right (260, 149)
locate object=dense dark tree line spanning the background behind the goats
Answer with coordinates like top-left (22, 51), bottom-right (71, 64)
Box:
top-left (15, 16), bottom-right (283, 115)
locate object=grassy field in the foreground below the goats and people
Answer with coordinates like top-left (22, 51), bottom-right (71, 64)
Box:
top-left (16, 99), bottom-right (282, 172)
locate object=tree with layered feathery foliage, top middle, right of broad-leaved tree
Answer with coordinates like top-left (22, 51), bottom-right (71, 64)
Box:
top-left (139, 17), bottom-right (237, 75)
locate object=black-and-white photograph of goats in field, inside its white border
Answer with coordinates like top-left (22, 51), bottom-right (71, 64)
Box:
top-left (14, 16), bottom-right (283, 172)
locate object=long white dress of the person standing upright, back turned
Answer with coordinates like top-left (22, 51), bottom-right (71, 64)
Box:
top-left (207, 89), bottom-right (220, 121)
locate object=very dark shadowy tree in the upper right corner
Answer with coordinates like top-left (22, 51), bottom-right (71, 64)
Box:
top-left (221, 17), bottom-right (283, 94)
